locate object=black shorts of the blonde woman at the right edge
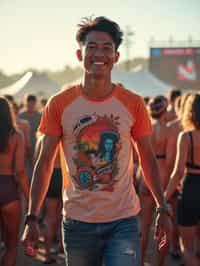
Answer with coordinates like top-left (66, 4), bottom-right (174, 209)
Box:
top-left (177, 174), bottom-right (200, 227)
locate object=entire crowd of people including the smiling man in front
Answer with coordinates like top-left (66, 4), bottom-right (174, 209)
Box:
top-left (0, 17), bottom-right (200, 266)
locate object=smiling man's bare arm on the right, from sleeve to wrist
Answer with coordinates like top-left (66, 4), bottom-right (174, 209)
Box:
top-left (136, 136), bottom-right (164, 207)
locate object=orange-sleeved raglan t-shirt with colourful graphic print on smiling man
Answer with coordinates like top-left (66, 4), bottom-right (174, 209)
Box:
top-left (39, 85), bottom-right (152, 223)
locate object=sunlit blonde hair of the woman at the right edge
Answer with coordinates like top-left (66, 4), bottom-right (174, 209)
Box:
top-left (181, 93), bottom-right (200, 130)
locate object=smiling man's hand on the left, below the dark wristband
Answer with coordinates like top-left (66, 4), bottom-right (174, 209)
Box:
top-left (21, 222), bottom-right (40, 257)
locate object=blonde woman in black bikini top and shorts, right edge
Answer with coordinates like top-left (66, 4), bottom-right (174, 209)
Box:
top-left (165, 94), bottom-right (200, 266)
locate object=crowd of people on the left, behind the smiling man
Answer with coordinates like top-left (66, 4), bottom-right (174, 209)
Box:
top-left (0, 94), bottom-right (62, 266)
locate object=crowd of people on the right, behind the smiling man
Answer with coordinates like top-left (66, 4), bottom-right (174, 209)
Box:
top-left (138, 90), bottom-right (200, 265)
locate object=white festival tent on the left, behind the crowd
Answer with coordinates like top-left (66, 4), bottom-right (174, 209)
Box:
top-left (0, 72), bottom-right (60, 100)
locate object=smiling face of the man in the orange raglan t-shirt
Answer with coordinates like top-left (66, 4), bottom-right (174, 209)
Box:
top-left (77, 31), bottom-right (119, 79)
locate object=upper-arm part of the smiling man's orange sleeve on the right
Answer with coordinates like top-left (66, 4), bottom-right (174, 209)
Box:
top-left (131, 96), bottom-right (152, 140)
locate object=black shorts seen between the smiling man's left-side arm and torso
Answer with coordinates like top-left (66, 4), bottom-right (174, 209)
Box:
top-left (46, 168), bottom-right (62, 199)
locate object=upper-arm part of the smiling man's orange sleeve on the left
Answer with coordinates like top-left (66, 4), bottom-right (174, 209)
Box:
top-left (38, 98), bottom-right (62, 136)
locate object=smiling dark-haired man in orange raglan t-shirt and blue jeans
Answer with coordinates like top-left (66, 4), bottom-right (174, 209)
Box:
top-left (21, 17), bottom-right (170, 266)
